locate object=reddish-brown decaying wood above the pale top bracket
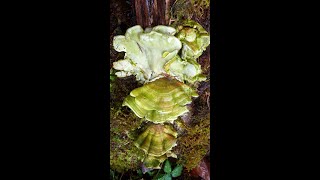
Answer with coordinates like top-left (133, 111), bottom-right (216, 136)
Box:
top-left (134, 0), bottom-right (174, 28)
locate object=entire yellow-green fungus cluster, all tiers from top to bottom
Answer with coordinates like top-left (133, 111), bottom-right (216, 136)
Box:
top-left (113, 20), bottom-right (210, 169)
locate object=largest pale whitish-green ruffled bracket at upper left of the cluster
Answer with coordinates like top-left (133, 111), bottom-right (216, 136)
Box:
top-left (113, 25), bottom-right (182, 83)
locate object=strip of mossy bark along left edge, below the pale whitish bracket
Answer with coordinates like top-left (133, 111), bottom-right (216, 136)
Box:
top-left (110, 77), bottom-right (144, 173)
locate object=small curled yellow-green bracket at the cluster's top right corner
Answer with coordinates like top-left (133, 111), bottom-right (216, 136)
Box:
top-left (176, 20), bottom-right (210, 60)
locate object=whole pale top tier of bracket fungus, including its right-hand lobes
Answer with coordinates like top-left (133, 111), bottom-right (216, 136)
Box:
top-left (113, 25), bottom-right (208, 83)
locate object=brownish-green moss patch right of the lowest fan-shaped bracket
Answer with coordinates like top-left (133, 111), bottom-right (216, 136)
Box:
top-left (173, 113), bottom-right (210, 171)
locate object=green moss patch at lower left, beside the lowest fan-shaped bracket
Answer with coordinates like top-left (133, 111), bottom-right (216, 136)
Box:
top-left (110, 106), bottom-right (144, 173)
